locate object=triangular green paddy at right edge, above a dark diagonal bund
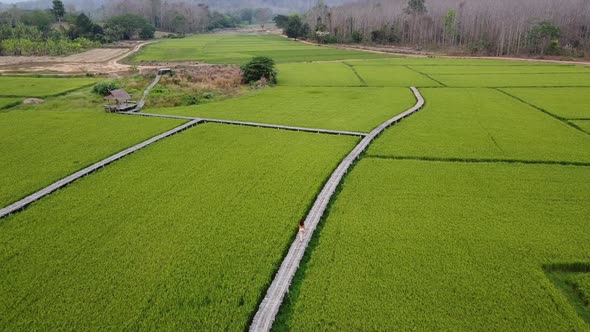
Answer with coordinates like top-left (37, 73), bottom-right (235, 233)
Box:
top-left (503, 88), bottom-right (590, 119)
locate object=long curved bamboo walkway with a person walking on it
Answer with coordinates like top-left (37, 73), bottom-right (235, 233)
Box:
top-left (250, 87), bottom-right (424, 332)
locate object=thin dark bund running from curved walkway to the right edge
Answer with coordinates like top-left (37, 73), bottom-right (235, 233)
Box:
top-left (365, 154), bottom-right (590, 167)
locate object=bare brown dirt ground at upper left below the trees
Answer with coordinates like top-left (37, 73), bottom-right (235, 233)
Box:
top-left (0, 41), bottom-right (153, 75)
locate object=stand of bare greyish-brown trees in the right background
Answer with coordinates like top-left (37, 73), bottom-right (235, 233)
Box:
top-left (304, 0), bottom-right (590, 56)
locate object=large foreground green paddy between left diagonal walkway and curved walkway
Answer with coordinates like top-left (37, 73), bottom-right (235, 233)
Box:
top-left (0, 124), bottom-right (358, 331)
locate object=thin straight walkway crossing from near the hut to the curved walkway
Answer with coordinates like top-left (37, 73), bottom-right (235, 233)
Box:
top-left (119, 111), bottom-right (369, 137)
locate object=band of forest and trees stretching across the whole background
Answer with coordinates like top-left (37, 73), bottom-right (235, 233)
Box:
top-left (0, 0), bottom-right (590, 57)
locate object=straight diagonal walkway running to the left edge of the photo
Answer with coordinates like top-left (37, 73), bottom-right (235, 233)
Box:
top-left (0, 119), bottom-right (203, 219)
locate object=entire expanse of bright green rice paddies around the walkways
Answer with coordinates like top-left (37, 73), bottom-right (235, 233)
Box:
top-left (0, 35), bottom-right (590, 331)
